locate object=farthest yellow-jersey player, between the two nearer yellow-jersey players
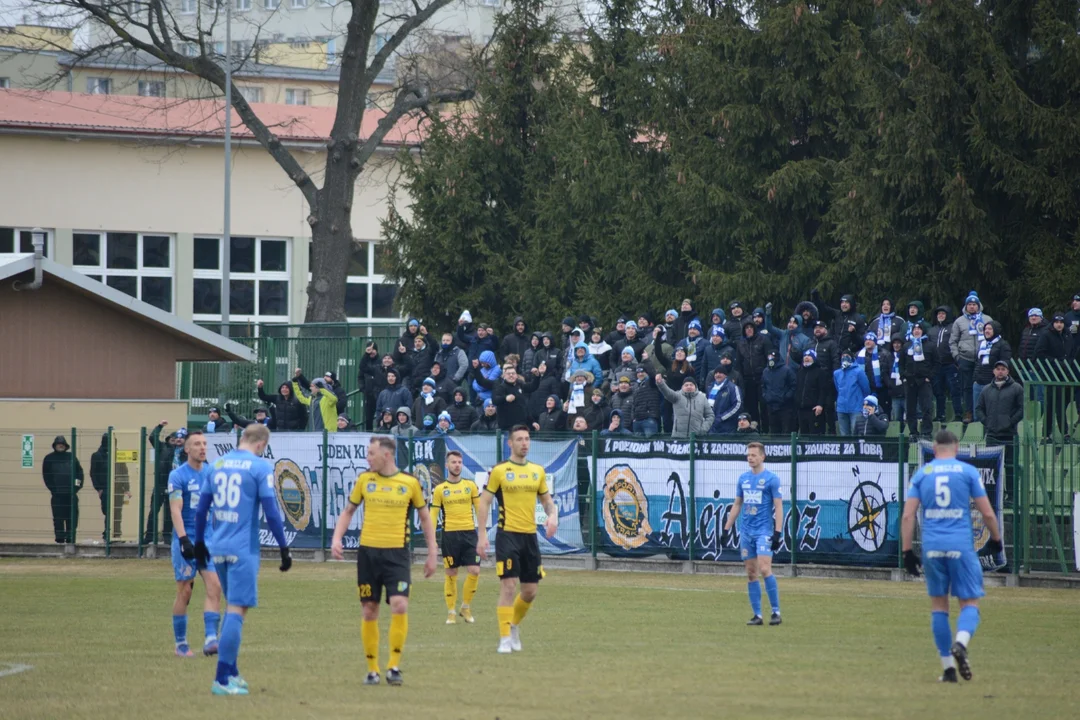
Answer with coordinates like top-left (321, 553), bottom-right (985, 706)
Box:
top-left (431, 450), bottom-right (480, 625)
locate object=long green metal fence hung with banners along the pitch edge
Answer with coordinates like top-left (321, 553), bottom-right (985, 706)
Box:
top-left (0, 427), bottom-right (1067, 573)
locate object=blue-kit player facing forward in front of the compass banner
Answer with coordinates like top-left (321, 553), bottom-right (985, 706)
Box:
top-left (724, 443), bottom-right (784, 625)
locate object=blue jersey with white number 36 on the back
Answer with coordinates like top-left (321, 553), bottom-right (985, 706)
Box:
top-left (202, 450), bottom-right (275, 561)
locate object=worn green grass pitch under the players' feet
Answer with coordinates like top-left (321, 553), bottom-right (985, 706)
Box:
top-left (0, 559), bottom-right (1080, 720)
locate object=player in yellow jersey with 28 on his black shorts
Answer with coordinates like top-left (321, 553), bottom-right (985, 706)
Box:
top-left (330, 435), bottom-right (435, 685)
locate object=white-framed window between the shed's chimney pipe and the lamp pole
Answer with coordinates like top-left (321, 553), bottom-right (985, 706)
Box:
top-left (71, 232), bottom-right (173, 312)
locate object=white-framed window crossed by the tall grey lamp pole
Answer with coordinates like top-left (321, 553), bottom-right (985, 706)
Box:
top-left (191, 236), bottom-right (289, 323)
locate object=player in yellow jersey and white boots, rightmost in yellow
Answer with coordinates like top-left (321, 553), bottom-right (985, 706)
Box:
top-left (476, 425), bottom-right (558, 653)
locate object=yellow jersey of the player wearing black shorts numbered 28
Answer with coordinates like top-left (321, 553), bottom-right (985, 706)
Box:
top-left (349, 471), bottom-right (428, 547)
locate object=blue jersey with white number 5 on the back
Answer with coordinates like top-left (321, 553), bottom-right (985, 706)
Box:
top-left (907, 459), bottom-right (986, 552)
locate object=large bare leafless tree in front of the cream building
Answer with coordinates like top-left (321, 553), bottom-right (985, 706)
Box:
top-left (19, 0), bottom-right (474, 323)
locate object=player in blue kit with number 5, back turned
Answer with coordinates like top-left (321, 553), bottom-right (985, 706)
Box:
top-left (901, 430), bottom-right (1001, 682)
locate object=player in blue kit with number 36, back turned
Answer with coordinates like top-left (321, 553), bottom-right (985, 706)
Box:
top-left (194, 424), bottom-right (293, 695)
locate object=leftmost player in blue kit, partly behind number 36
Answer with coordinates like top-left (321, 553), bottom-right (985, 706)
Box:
top-left (167, 431), bottom-right (221, 657)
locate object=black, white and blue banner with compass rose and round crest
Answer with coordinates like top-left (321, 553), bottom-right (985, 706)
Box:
top-left (595, 438), bottom-right (904, 567)
